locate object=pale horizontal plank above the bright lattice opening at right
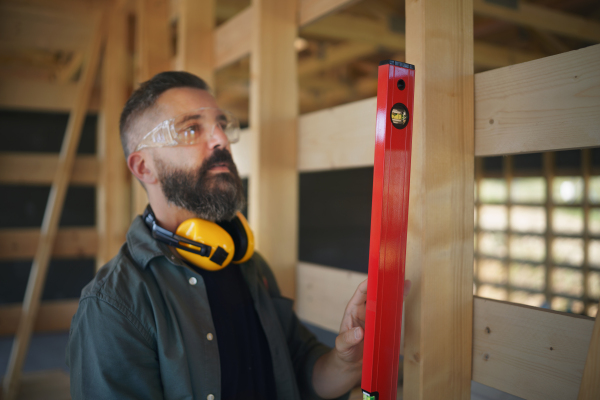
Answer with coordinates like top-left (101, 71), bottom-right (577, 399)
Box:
top-left (475, 45), bottom-right (600, 156)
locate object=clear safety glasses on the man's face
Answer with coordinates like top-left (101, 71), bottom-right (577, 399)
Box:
top-left (135, 107), bottom-right (240, 151)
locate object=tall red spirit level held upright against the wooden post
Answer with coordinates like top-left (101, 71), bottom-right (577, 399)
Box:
top-left (361, 60), bottom-right (415, 400)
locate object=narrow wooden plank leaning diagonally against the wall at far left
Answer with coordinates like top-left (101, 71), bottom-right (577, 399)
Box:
top-left (3, 16), bottom-right (104, 400)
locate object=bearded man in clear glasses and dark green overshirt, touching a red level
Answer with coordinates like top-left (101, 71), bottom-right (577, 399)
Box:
top-left (67, 72), bottom-right (382, 400)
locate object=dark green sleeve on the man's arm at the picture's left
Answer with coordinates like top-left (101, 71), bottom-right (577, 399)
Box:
top-left (66, 297), bottom-right (163, 400)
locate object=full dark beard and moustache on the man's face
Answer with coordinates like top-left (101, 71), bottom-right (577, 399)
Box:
top-left (154, 149), bottom-right (245, 222)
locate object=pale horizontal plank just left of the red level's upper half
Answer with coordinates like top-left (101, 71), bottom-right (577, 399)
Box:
top-left (298, 97), bottom-right (377, 172)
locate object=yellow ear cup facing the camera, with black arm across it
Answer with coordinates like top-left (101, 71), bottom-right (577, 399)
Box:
top-left (176, 218), bottom-right (235, 271)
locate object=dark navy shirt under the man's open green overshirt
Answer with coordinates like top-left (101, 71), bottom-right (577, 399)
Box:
top-left (188, 264), bottom-right (277, 400)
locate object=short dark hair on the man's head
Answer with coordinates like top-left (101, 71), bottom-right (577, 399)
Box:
top-left (119, 71), bottom-right (210, 158)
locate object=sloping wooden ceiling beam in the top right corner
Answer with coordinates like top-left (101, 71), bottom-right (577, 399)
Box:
top-left (473, 0), bottom-right (600, 43)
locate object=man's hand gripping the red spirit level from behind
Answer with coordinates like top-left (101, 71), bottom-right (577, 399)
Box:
top-left (312, 280), bottom-right (411, 398)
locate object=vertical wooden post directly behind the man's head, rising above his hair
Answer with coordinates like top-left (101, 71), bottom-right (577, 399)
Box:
top-left (131, 0), bottom-right (173, 216)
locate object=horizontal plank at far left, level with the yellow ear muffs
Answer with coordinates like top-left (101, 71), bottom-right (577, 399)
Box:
top-left (0, 227), bottom-right (98, 261)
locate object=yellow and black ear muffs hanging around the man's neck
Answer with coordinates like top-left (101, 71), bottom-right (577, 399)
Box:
top-left (143, 206), bottom-right (254, 271)
